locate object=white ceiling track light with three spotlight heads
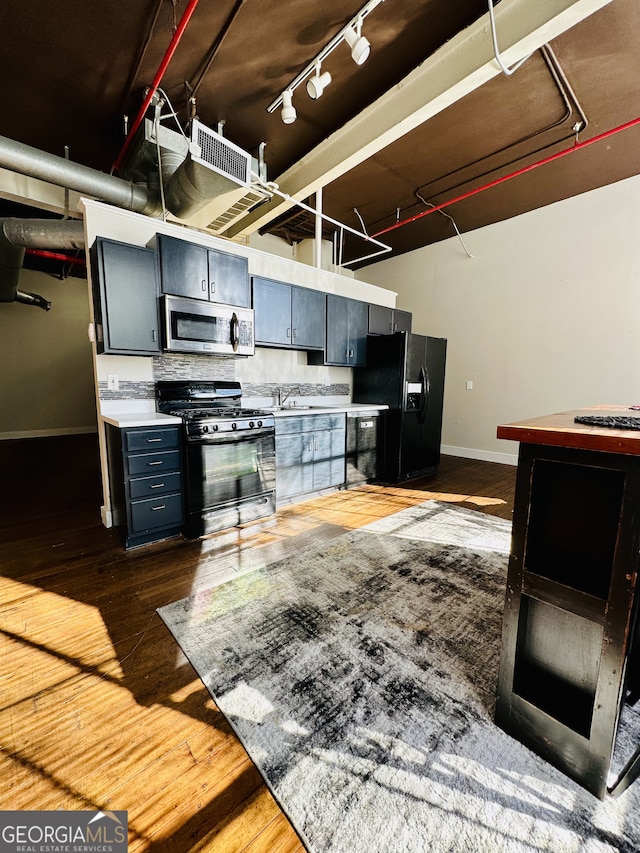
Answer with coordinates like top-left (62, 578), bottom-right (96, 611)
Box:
top-left (267, 0), bottom-right (384, 124)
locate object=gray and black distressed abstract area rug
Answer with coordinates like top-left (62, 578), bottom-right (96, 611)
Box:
top-left (159, 501), bottom-right (640, 853)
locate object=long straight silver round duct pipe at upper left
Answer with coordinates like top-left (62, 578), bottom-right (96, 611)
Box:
top-left (0, 136), bottom-right (161, 216)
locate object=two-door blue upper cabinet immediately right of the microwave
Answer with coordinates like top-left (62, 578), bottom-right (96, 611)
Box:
top-left (253, 276), bottom-right (325, 350)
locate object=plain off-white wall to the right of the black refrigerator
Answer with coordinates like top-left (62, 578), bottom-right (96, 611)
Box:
top-left (362, 177), bottom-right (640, 462)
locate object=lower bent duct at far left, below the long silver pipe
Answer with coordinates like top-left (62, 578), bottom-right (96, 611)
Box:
top-left (0, 218), bottom-right (84, 311)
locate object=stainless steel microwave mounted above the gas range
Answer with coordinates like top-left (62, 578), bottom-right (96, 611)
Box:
top-left (162, 296), bottom-right (255, 355)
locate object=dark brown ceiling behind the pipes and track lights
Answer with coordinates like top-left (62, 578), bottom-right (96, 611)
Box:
top-left (0, 0), bottom-right (640, 270)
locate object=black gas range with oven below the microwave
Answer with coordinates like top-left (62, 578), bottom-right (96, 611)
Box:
top-left (156, 380), bottom-right (276, 538)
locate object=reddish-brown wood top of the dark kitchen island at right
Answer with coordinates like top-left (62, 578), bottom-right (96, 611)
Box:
top-left (497, 405), bottom-right (640, 456)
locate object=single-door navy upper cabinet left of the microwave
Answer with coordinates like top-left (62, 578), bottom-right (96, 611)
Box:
top-left (90, 237), bottom-right (160, 355)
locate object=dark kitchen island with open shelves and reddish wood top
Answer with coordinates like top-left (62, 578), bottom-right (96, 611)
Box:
top-left (496, 406), bottom-right (640, 799)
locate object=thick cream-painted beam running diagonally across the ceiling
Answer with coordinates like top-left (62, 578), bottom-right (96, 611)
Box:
top-left (225, 0), bottom-right (611, 237)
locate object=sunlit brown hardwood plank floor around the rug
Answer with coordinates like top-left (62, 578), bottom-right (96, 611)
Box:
top-left (0, 435), bottom-right (515, 853)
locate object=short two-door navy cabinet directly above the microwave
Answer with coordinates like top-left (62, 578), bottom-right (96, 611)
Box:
top-left (158, 234), bottom-right (251, 308)
